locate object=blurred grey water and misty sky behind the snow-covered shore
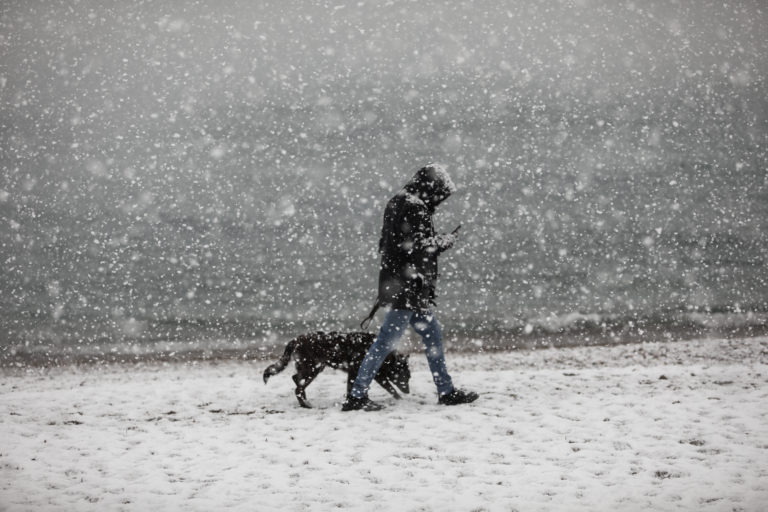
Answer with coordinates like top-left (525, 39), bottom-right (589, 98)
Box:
top-left (0, 0), bottom-right (768, 364)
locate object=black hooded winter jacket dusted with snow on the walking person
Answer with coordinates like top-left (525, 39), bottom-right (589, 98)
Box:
top-left (378, 164), bottom-right (456, 312)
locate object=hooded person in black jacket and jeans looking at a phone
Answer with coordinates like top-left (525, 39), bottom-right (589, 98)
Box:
top-left (342, 164), bottom-right (478, 411)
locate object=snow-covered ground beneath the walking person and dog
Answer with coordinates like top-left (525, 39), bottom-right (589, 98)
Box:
top-left (0, 338), bottom-right (768, 511)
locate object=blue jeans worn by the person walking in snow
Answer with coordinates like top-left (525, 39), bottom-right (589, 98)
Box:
top-left (350, 309), bottom-right (453, 398)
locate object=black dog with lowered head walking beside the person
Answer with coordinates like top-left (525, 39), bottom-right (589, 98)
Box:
top-left (264, 332), bottom-right (411, 408)
